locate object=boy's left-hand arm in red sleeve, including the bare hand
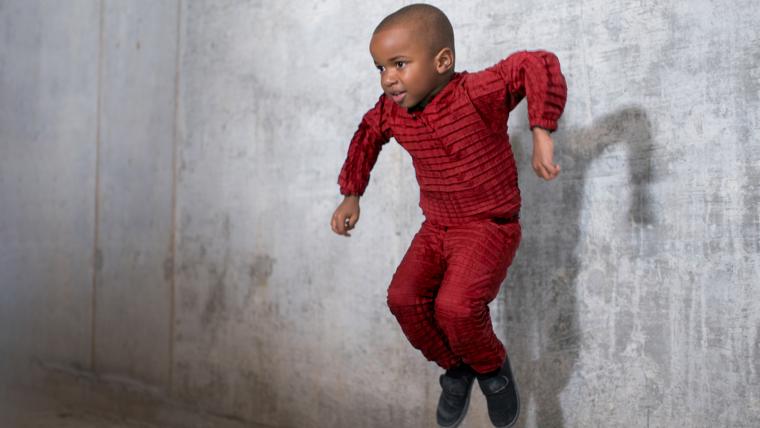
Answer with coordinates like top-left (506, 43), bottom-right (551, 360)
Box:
top-left (330, 94), bottom-right (391, 236)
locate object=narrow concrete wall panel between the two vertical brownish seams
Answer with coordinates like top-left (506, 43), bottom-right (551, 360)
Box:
top-left (93, 1), bottom-right (179, 384)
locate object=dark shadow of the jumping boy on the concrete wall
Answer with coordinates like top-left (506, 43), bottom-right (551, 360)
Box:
top-left (497, 107), bottom-right (654, 427)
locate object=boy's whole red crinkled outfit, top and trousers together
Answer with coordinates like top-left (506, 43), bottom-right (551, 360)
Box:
top-left (338, 51), bottom-right (567, 372)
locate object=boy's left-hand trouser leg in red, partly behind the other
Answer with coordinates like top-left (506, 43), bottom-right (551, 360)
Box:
top-left (388, 221), bottom-right (461, 369)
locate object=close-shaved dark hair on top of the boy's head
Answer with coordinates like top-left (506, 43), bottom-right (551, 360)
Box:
top-left (373, 3), bottom-right (454, 55)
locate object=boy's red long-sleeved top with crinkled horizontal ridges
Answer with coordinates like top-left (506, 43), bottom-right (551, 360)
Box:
top-left (338, 51), bottom-right (567, 225)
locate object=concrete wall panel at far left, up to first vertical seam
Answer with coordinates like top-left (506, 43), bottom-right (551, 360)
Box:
top-left (0, 1), bottom-right (99, 373)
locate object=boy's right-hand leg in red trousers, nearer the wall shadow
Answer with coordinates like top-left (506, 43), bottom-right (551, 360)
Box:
top-left (435, 220), bottom-right (521, 373)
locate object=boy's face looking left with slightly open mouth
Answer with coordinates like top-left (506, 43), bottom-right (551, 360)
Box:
top-left (369, 25), bottom-right (443, 109)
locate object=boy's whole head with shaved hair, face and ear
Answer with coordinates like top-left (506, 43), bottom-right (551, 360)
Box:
top-left (369, 4), bottom-right (454, 108)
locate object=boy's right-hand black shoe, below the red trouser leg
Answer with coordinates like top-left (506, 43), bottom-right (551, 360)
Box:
top-left (478, 357), bottom-right (520, 428)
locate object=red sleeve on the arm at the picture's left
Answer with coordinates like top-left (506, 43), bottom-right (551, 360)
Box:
top-left (338, 94), bottom-right (391, 195)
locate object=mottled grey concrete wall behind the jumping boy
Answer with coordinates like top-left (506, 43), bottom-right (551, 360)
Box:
top-left (0, 0), bottom-right (760, 428)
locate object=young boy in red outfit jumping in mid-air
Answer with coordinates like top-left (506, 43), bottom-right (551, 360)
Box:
top-left (331, 4), bottom-right (567, 427)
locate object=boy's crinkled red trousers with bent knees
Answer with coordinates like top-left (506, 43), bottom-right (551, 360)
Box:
top-left (388, 218), bottom-right (521, 373)
